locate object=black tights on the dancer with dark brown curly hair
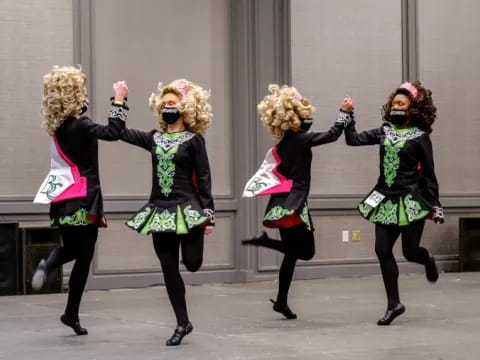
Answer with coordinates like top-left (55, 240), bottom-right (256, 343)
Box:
top-left (375, 220), bottom-right (430, 309)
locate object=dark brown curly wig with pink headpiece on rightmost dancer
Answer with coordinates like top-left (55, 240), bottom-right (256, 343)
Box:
top-left (382, 80), bottom-right (437, 133)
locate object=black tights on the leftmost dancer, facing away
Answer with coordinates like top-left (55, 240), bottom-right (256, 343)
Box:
top-left (47, 226), bottom-right (98, 321)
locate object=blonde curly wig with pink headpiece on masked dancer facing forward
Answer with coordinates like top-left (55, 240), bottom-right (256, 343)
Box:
top-left (148, 79), bottom-right (213, 135)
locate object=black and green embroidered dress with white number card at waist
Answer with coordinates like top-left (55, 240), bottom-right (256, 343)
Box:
top-left (345, 121), bottom-right (441, 226)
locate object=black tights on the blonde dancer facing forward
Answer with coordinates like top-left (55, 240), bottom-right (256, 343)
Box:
top-left (153, 228), bottom-right (203, 326)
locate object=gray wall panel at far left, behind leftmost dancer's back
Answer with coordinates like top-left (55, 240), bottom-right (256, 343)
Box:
top-left (0, 0), bottom-right (73, 197)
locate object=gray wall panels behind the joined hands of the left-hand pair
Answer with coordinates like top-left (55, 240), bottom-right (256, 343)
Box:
top-left (85, 0), bottom-right (234, 284)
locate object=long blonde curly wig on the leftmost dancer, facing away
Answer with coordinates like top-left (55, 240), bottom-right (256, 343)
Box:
top-left (42, 65), bottom-right (87, 135)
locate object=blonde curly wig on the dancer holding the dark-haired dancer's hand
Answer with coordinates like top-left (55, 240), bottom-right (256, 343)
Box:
top-left (258, 84), bottom-right (316, 139)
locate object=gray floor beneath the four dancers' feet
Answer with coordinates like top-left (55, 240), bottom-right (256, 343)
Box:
top-left (0, 273), bottom-right (480, 360)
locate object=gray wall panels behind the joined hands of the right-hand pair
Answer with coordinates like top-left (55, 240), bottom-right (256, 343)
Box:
top-left (291, 0), bottom-right (402, 266)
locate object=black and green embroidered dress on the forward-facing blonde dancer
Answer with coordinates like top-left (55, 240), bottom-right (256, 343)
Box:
top-left (121, 129), bottom-right (215, 235)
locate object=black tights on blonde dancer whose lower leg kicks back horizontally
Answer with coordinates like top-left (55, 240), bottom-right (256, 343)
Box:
top-left (261, 224), bottom-right (315, 306)
